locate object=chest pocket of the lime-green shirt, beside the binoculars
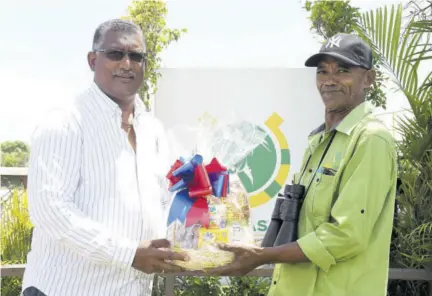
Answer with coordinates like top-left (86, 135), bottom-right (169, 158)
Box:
top-left (311, 173), bottom-right (336, 222)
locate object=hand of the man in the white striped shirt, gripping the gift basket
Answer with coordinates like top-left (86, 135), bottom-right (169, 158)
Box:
top-left (132, 239), bottom-right (188, 274)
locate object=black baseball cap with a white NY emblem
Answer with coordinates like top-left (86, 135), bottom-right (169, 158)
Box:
top-left (305, 33), bottom-right (372, 69)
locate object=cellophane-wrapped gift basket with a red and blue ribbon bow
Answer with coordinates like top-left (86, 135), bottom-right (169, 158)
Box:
top-left (166, 118), bottom-right (265, 270)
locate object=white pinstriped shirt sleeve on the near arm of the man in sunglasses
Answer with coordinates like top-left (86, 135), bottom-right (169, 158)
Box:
top-left (28, 112), bottom-right (139, 266)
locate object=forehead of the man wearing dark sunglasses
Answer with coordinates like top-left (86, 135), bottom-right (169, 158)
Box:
top-left (102, 31), bottom-right (145, 50)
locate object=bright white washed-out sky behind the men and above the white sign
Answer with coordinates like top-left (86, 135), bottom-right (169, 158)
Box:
top-left (0, 0), bottom-right (412, 142)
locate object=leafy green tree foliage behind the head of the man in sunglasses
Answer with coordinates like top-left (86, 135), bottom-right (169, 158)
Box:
top-left (123, 0), bottom-right (187, 108)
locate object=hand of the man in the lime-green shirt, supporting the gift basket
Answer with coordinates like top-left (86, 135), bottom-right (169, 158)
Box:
top-left (205, 245), bottom-right (265, 276)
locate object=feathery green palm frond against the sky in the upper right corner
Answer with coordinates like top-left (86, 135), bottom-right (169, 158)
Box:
top-left (355, 4), bottom-right (430, 115)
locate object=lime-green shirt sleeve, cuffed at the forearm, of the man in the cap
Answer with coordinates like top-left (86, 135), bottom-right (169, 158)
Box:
top-left (297, 135), bottom-right (396, 271)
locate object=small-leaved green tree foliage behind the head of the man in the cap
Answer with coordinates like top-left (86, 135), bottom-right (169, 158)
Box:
top-left (304, 1), bottom-right (386, 109)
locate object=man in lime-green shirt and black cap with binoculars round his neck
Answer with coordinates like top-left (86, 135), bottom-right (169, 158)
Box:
top-left (208, 34), bottom-right (397, 296)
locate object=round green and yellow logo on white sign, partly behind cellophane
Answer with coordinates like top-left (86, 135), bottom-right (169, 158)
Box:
top-left (200, 113), bottom-right (290, 208)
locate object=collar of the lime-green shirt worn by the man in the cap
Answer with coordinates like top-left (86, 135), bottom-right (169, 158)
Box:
top-left (309, 102), bottom-right (372, 136)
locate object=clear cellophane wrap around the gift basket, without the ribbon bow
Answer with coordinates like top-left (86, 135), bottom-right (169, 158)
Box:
top-left (167, 115), bottom-right (266, 270)
